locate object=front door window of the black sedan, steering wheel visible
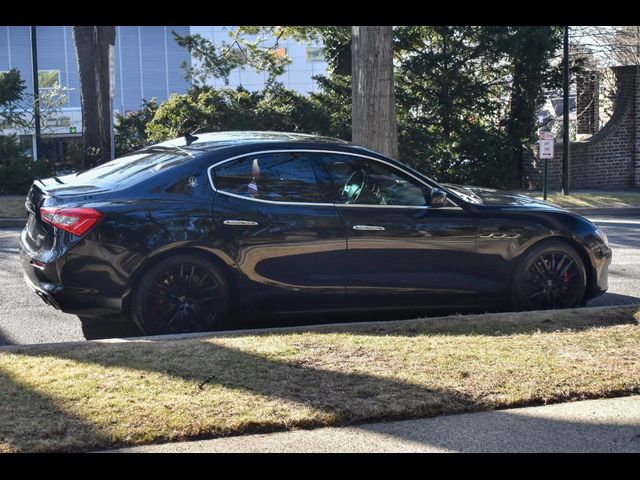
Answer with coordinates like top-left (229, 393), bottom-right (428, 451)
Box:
top-left (321, 154), bottom-right (429, 206)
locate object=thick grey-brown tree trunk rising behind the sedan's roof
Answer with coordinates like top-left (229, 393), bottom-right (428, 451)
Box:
top-left (351, 26), bottom-right (398, 158)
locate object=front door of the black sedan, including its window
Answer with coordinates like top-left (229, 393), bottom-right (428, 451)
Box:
top-left (319, 154), bottom-right (477, 307)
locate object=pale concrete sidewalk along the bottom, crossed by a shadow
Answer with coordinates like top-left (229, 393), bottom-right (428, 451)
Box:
top-left (109, 396), bottom-right (640, 453)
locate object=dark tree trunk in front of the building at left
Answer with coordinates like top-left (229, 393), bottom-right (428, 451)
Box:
top-left (73, 26), bottom-right (116, 168)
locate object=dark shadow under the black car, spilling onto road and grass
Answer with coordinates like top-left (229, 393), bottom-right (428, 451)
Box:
top-left (80, 300), bottom-right (640, 341)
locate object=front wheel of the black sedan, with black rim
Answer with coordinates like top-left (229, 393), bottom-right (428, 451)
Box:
top-left (511, 240), bottom-right (587, 310)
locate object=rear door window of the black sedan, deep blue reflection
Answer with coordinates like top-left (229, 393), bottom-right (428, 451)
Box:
top-left (213, 152), bottom-right (322, 203)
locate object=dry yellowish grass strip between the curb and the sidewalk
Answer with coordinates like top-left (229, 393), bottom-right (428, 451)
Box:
top-left (0, 307), bottom-right (640, 452)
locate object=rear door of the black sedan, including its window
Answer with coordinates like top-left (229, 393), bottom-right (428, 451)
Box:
top-left (210, 151), bottom-right (346, 311)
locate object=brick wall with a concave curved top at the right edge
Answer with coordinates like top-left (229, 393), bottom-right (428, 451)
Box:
top-left (524, 66), bottom-right (640, 190)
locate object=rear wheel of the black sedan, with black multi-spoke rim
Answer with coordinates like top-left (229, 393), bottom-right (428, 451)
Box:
top-left (131, 254), bottom-right (230, 335)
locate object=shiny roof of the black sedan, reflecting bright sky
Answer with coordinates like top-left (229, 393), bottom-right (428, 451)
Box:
top-left (156, 131), bottom-right (352, 151)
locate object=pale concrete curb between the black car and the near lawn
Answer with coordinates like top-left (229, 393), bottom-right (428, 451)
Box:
top-left (0, 304), bottom-right (640, 351)
